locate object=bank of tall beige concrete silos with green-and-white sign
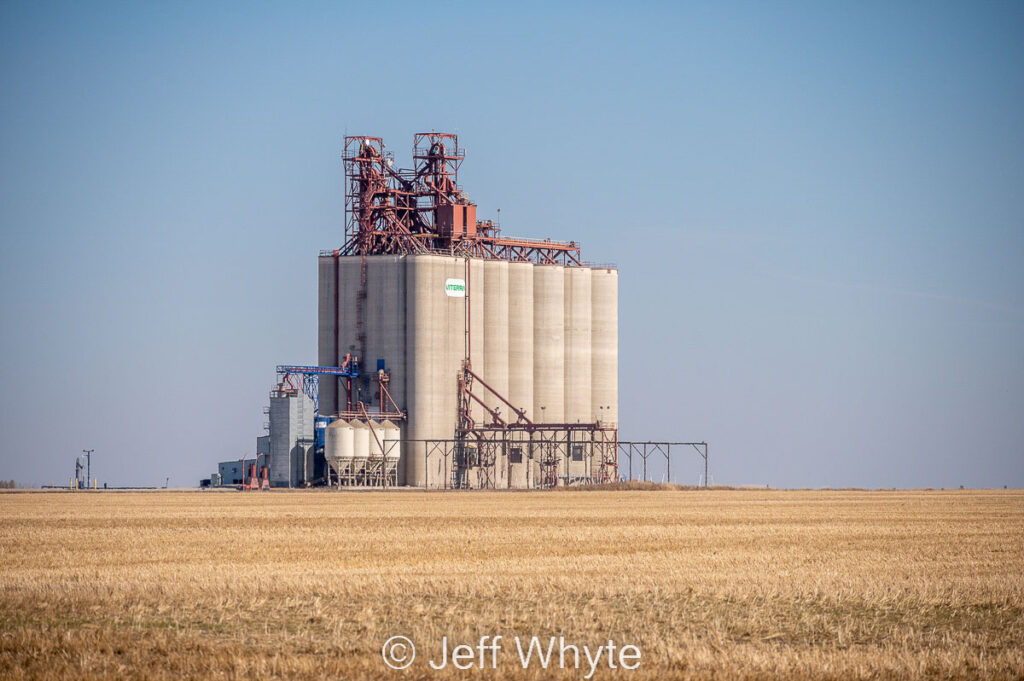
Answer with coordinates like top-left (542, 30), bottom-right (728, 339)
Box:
top-left (318, 254), bottom-right (618, 486)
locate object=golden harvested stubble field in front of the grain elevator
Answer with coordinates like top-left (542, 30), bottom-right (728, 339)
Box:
top-left (0, 491), bottom-right (1024, 681)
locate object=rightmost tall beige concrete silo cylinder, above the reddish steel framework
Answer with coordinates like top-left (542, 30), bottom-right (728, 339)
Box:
top-left (591, 267), bottom-right (618, 426)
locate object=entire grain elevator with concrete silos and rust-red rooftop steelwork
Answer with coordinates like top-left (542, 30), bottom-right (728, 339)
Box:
top-left (206, 132), bottom-right (707, 490)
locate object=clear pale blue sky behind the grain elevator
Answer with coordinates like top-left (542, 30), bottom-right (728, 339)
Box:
top-left (0, 2), bottom-right (1024, 487)
